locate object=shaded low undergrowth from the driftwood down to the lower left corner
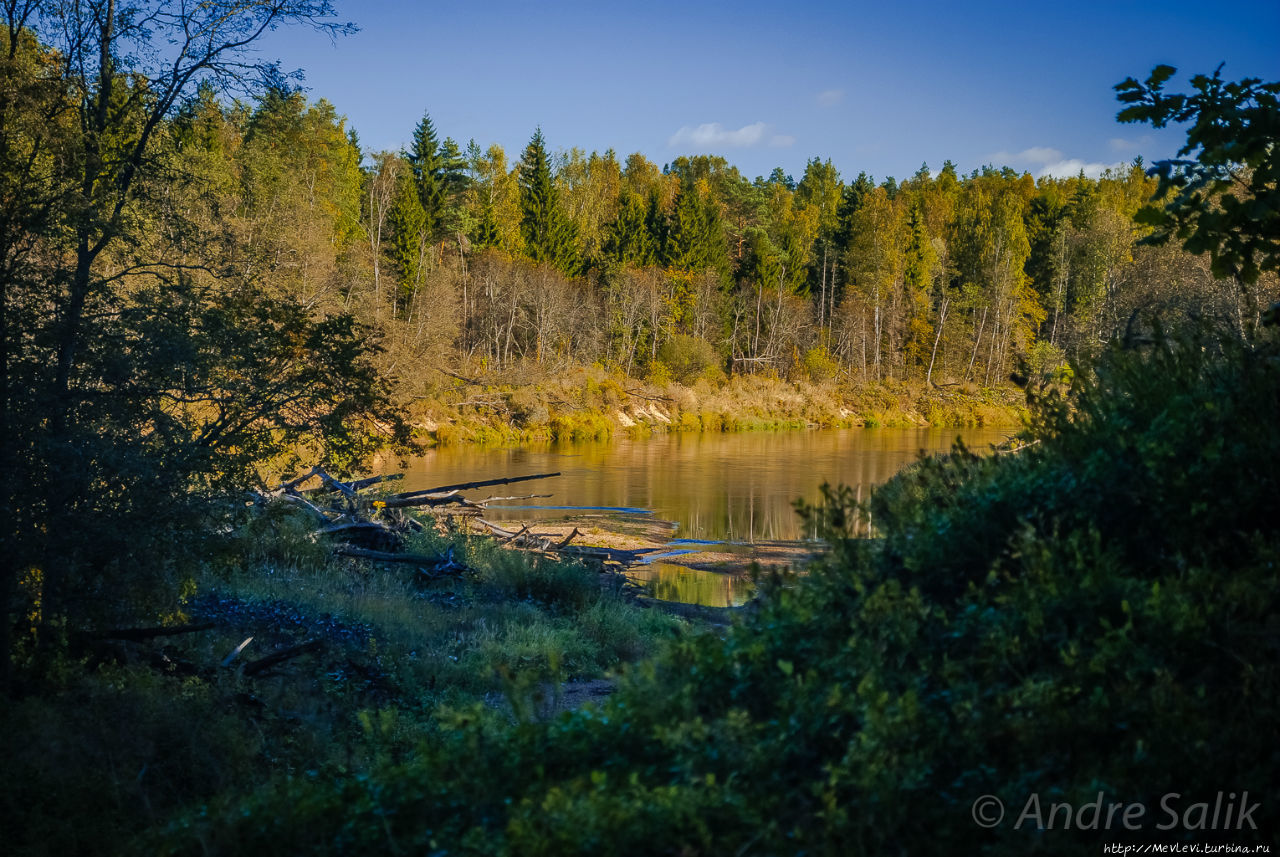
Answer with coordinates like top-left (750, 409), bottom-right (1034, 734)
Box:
top-left (0, 507), bottom-right (685, 854)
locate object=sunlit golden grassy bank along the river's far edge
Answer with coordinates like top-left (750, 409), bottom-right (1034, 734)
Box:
top-left (410, 366), bottom-right (1027, 445)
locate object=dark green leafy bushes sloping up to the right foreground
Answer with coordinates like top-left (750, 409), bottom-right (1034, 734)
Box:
top-left (160, 330), bottom-right (1280, 856)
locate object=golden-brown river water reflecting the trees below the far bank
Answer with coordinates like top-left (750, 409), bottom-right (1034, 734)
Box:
top-left (389, 429), bottom-right (1012, 542)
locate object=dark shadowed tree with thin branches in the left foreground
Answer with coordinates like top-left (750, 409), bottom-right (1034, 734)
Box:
top-left (0, 0), bottom-right (404, 683)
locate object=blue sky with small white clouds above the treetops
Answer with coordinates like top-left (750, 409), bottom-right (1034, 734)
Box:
top-left (262, 0), bottom-right (1280, 179)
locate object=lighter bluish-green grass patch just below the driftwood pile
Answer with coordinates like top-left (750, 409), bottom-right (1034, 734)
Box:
top-left (205, 516), bottom-right (680, 706)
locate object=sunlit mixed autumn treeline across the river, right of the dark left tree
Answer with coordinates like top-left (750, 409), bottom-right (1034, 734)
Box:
top-left (157, 91), bottom-right (1257, 385)
